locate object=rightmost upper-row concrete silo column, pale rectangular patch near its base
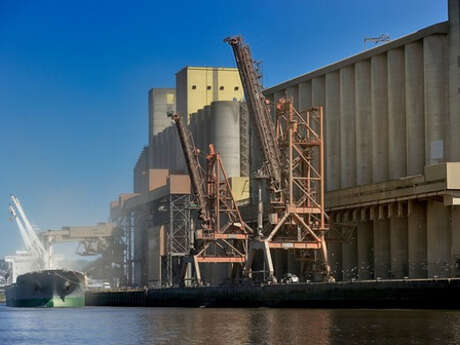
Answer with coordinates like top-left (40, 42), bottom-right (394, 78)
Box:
top-left (423, 35), bottom-right (450, 165)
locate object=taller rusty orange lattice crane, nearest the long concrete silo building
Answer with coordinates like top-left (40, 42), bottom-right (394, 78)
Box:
top-left (225, 36), bottom-right (332, 281)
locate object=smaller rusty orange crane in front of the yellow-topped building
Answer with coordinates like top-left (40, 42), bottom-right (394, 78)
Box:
top-left (169, 114), bottom-right (252, 285)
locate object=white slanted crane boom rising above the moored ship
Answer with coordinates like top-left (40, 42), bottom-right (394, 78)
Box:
top-left (10, 195), bottom-right (51, 269)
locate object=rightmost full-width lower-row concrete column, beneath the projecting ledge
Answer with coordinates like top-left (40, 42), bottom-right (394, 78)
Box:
top-left (426, 200), bottom-right (451, 277)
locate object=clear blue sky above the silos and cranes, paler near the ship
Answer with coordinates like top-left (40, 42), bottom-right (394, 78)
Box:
top-left (0, 0), bottom-right (447, 257)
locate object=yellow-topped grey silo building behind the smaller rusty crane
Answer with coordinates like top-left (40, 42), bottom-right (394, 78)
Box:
top-left (111, 67), bottom-right (249, 286)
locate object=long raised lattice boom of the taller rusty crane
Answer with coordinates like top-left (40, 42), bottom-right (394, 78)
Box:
top-left (224, 36), bottom-right (282, 191)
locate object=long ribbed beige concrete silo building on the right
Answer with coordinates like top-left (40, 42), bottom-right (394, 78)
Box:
top-left (265, 1), bottom-right (460, 279)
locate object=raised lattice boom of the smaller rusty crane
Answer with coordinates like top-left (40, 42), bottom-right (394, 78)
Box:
top-left (168, 113), bottom-right (210, 223)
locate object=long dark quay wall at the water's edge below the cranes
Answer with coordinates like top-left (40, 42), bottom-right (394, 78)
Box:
top-left (86, 278), bottom-right (460, 309)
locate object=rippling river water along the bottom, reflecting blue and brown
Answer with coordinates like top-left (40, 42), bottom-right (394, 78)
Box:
top-left (0, 305), bottom-right (460, 345)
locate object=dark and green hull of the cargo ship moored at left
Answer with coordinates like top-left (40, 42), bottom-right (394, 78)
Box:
top-left (5, 269), bottom-right (87, 308)
